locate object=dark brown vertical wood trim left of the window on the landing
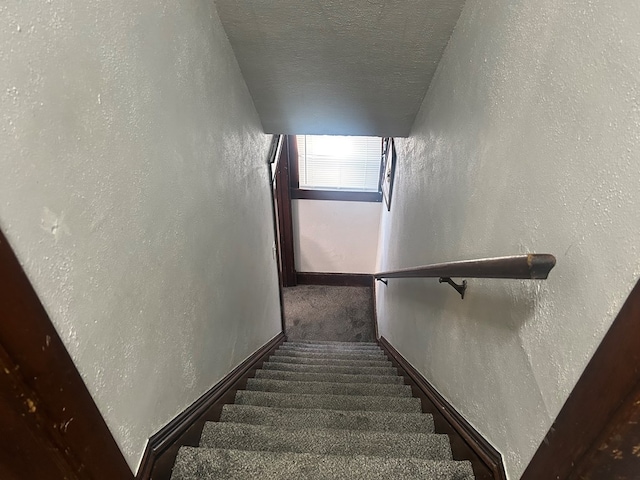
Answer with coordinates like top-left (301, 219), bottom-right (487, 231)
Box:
top-left (276, 140), bottom-right (296, 287)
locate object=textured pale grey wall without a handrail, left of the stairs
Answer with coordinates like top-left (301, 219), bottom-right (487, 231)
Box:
top-left (0, 0), bottom-right (280, 470)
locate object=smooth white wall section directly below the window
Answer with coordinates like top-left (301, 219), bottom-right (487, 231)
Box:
top-left (291, 200), bottom-right (382, 273)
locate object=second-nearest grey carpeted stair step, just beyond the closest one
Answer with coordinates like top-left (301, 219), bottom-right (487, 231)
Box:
top-left (200, 422), bottom-right (453, 460)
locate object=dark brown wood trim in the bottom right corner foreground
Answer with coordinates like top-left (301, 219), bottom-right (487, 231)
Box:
top-left (522, 281), bottom-right (640, 480)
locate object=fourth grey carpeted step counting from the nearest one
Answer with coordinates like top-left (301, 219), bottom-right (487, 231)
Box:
top-left (235, 390), bottom-right (422, 413)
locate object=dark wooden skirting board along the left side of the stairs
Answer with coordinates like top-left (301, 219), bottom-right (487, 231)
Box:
top-left (136, 333), bottom-right (286, 480)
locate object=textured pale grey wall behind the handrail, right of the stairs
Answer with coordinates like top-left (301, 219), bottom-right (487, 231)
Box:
top-left (377, 0), bottom-right (640, 479)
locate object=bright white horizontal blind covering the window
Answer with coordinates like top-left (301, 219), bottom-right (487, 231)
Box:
top-left (296, 135), bottom-right (382, 192)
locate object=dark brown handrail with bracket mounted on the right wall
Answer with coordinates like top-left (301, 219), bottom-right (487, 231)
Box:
top-left (373, 253), bottom-right (556, 298)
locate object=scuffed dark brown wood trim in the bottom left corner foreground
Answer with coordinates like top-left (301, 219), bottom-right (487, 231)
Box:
top-left (0, 232), bottom-right (133, 480)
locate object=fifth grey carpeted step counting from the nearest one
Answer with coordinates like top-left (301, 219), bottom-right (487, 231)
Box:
top-left (246, 378), bottom-right (411, 397)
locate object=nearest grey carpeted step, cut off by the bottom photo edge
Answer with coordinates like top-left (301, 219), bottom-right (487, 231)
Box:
top-left (172, 447), bottom-right (473, 480)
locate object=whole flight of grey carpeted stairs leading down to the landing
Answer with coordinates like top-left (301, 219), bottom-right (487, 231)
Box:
top-left (171, 342), bottom-right (474, 480)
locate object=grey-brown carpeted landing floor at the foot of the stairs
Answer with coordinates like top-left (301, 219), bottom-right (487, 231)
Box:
top-left (284, 285), bottom-right (375, 342)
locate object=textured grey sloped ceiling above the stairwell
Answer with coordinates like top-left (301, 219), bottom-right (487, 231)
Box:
top-left (216, 0), bottom-right (464, 136)
